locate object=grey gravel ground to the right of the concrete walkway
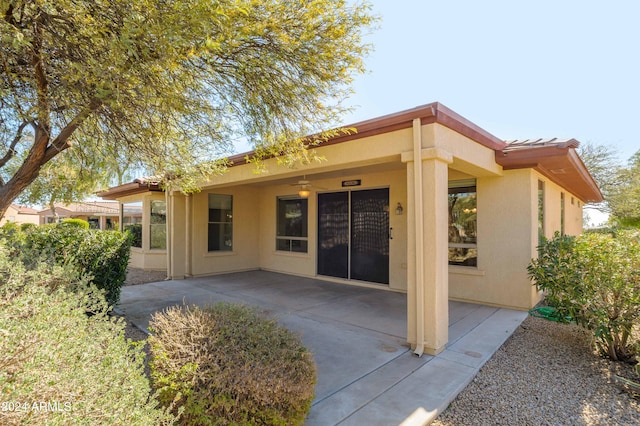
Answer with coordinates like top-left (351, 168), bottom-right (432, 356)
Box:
top-left (432, 317), bottom-right (640, 426)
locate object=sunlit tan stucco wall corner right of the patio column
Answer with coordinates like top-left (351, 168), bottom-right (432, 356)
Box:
top-left (449, 169), bottom-right (582, 310)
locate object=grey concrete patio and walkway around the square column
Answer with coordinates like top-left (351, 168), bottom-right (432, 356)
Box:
top-left (117, 271), bottom-right (527, 426)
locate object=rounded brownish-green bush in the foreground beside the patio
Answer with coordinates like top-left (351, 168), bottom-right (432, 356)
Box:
top-left (149, 304), bottom-right (316, 425)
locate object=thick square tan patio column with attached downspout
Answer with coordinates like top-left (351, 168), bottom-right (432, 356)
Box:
top-left (402, 119), bottom-right (453, 356)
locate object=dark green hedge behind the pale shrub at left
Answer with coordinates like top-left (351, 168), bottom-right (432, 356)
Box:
top-left (0, 224), bottom-right (131, 305)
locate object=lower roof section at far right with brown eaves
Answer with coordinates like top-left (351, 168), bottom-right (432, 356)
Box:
top-left (496, 138), bottom-right (603, 203)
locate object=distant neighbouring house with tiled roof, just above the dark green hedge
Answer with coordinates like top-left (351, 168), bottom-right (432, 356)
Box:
top-left (38, 201), bottom-right (120, 230)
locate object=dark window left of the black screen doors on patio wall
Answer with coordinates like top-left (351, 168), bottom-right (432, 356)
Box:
top-left (276, 197), bottom-right (308, 253)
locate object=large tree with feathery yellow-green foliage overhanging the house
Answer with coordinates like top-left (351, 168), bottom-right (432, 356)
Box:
top-left (0, 0), bottom-right (372, 212)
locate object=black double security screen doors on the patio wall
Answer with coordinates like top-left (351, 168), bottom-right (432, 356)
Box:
top-left (318, 188), bottom-right (389, 284)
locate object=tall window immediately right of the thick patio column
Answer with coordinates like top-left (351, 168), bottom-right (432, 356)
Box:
top-left (449, 179), bottom-right (478, 266)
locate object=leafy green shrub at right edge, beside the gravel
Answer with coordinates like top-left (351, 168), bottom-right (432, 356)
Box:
top-left (528, 231), bottom-right (640, 360)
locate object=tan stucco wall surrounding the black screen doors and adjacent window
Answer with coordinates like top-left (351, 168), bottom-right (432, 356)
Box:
top-left (254, 170), bottom-right (407, 291)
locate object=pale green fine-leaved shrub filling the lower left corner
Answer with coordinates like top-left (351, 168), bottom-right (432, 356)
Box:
top-left (0, 246), bottom-right (175, 425)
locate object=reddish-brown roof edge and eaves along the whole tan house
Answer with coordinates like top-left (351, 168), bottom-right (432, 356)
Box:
top-left (98, 102), bottom-right (603, 202)
